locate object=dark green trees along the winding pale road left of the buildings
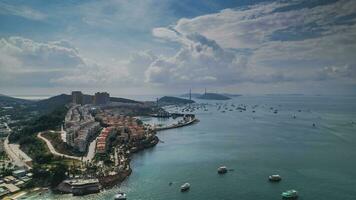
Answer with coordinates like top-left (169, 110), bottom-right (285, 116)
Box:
top-left (9, 106), bottom-right (68, 187)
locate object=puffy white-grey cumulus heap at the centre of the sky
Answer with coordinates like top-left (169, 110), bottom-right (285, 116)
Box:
top-left (146, 31), bottom-right (253, 84)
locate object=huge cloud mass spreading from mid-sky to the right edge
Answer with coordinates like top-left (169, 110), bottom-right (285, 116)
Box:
top-left (146, 0), bottom-right (356, 85)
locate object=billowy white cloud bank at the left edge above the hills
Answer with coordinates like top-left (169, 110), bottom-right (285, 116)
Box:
top-left (0, 37), bottom-right (105, 86)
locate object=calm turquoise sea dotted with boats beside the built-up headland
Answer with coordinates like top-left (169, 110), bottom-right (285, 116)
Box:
top-left (36, 96), bottom-right (356, 200)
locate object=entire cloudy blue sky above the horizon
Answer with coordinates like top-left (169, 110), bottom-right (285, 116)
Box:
top-left (0, 0), bottom-right (356, 96)
